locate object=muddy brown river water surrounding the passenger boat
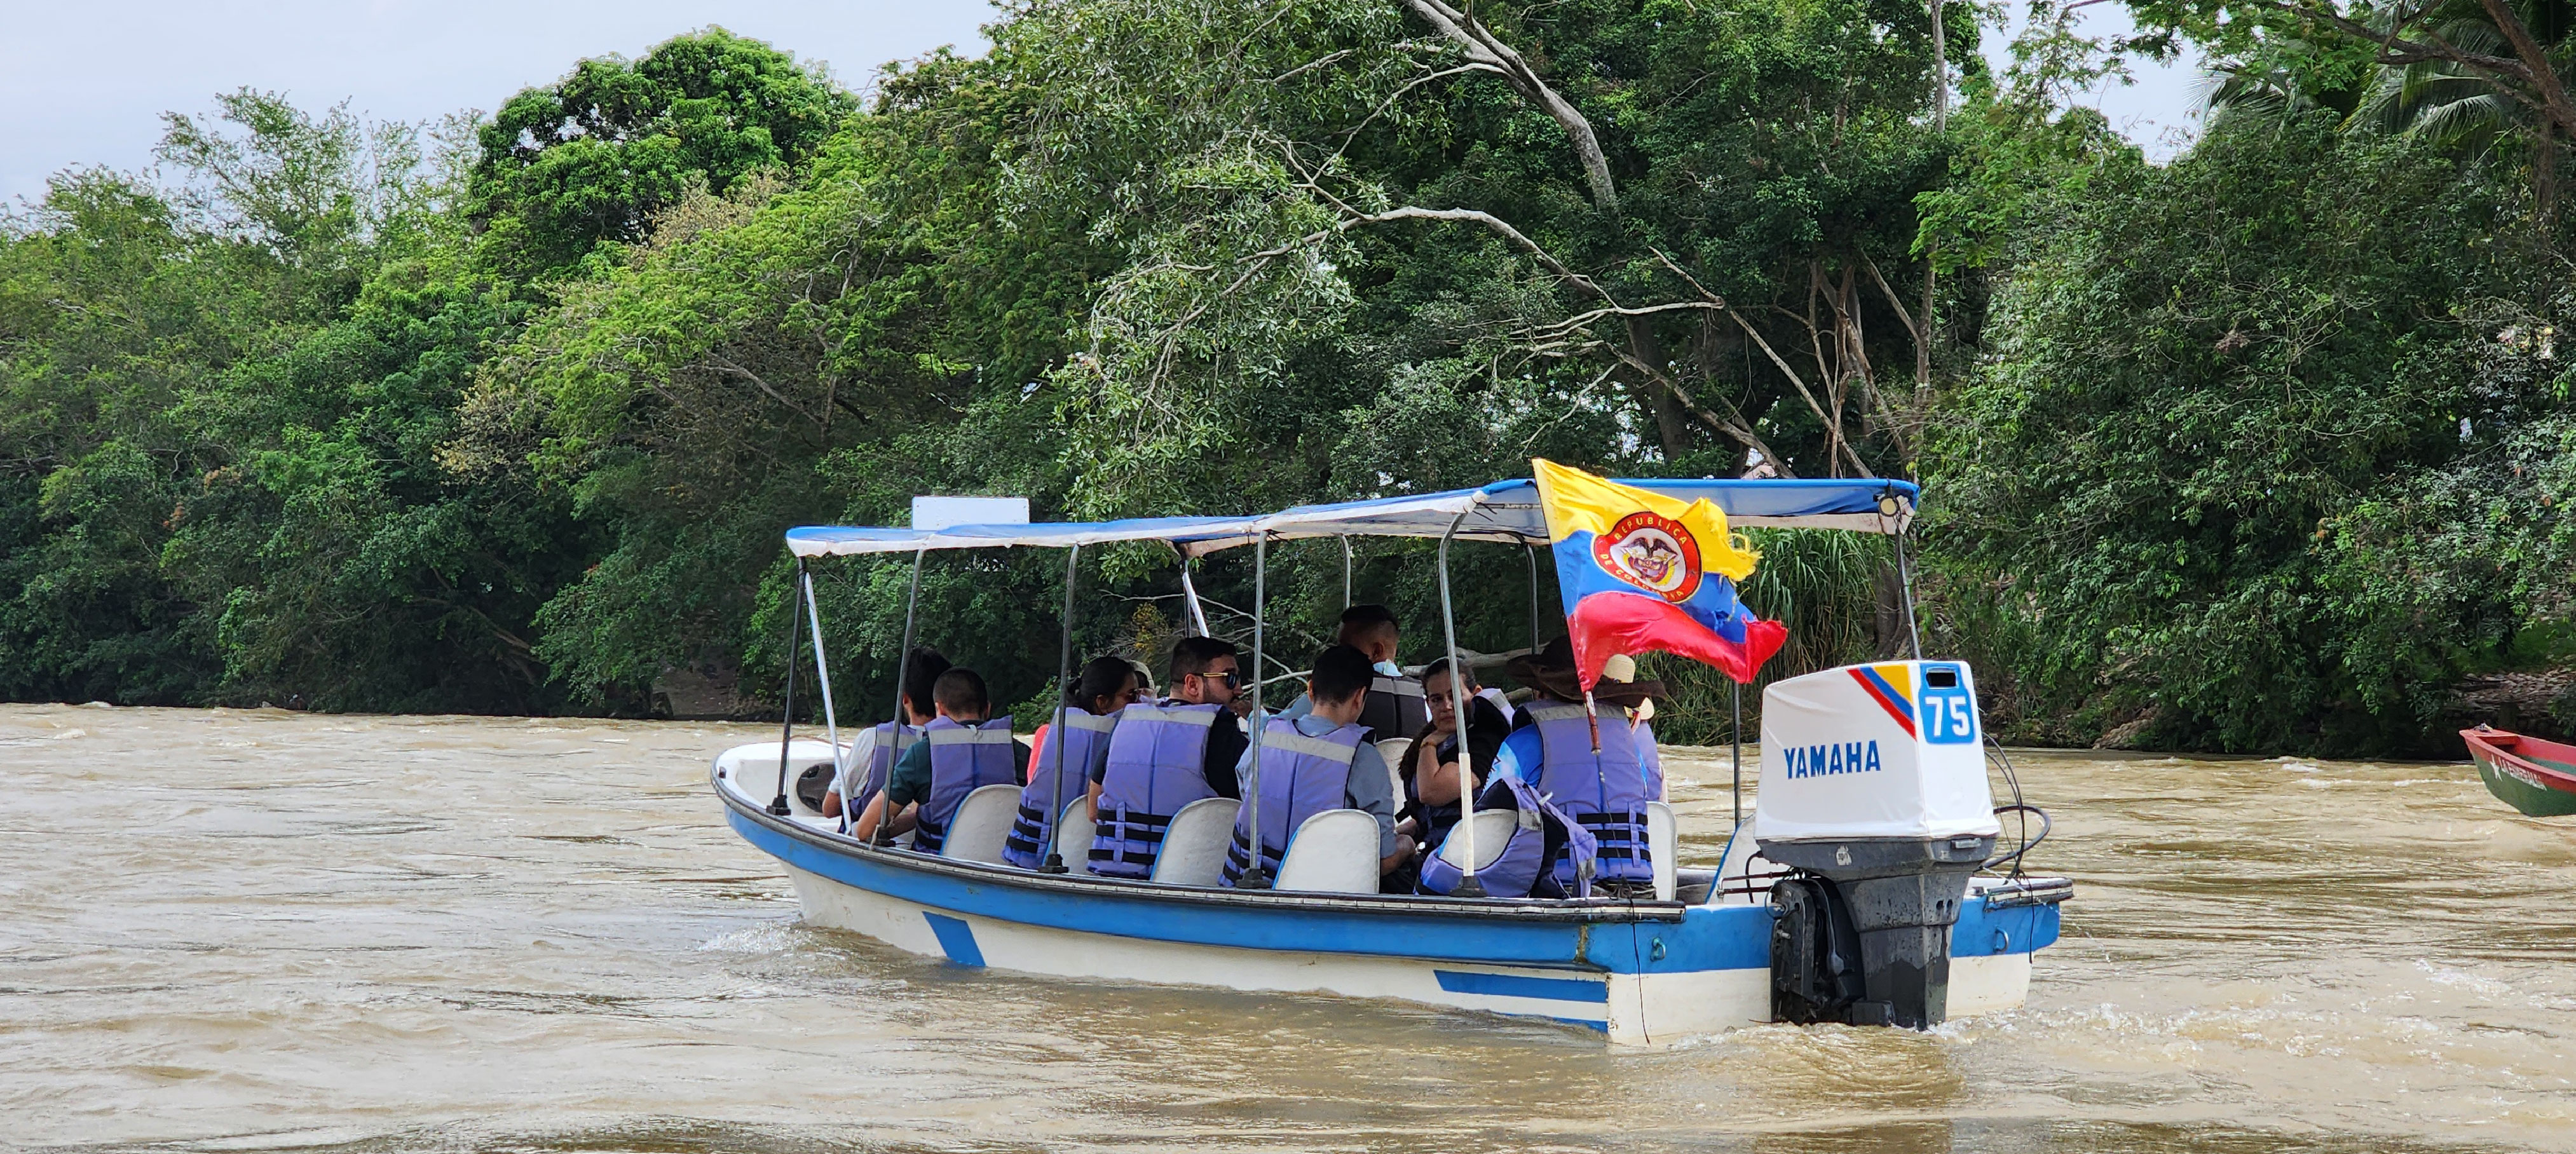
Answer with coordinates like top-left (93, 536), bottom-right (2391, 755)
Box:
top-left (0, 706), bottom-right (2576, 1154)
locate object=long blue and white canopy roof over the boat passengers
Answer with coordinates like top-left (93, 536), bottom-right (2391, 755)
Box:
top-left (788, 477), bottom-right (1919, 557)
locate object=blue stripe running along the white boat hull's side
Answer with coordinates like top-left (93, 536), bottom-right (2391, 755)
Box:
top-left (726, 806), bottom-right (2058, 979)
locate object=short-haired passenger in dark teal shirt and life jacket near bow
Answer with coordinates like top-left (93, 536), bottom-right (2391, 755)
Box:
top-left (850, 667), bottom-right (1028, 853)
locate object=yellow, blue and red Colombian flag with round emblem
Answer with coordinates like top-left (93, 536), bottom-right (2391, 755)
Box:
top-left (1530, 461), bottom-right (1788, 690)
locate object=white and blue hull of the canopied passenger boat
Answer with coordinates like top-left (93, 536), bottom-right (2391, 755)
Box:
top-left (716, 775), bottom-right (2066, 1046)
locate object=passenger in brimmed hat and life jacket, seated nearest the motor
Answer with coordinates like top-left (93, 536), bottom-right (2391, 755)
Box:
top-left (1476, 639), bottom-right (1664, 888)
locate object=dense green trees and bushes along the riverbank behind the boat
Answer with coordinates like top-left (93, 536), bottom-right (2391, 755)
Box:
top-left (0, 0), bottom-right (2576, 755)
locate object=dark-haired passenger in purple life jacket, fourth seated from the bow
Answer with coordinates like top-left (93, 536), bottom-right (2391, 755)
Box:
top-left (1226, 644), bottom-right (1414, 888)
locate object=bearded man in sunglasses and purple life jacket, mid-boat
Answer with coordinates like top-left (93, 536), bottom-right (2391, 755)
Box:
top-left (1089, 636), bottom-right (1247, 878)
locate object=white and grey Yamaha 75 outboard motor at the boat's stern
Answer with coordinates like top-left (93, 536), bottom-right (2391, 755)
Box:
top-left (1754, 662), bottom-right (2001, 1030)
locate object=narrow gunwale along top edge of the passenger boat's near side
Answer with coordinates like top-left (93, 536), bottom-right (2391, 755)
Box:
top-left (709, 775), bottom-right (1693, 925)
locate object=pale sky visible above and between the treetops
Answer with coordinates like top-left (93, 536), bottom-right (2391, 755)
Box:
top-left (0, 0), bottom-right (2197, 203)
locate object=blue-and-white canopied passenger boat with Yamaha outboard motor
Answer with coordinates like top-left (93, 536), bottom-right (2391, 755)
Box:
top-left (711, 479), bottom-right (2074, 1046)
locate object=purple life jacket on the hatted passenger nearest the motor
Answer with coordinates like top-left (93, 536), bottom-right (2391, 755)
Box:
top-left (1527, 703), bottom-right (1664, 886)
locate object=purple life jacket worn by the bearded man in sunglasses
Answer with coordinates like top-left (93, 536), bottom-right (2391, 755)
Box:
top-left (1092, 701), bottom-right (1231, 878)
